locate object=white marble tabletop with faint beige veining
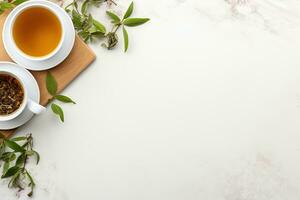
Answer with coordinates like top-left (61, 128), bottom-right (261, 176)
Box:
top-left (0, 0), bottom-right (300, 200)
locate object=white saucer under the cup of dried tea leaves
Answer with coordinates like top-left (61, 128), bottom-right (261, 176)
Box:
top-left (0, 62), bottom-right (40, 130)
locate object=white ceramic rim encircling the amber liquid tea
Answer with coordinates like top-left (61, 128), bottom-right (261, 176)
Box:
top-left (10, 2), bottom-right (65, 61)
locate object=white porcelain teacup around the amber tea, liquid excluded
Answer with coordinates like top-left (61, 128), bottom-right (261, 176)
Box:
top-left (9, 0), bottom-right (66, 61)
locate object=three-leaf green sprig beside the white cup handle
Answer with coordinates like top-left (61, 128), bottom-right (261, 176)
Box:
top-left (46, 71), bottom-right (76, 122)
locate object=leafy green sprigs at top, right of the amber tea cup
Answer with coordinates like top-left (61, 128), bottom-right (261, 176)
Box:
top-left (65, 0), bottom-right (150, 52)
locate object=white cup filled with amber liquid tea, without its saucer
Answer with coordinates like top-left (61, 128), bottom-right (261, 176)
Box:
top-left (10, 2), bottom-right (65, 61)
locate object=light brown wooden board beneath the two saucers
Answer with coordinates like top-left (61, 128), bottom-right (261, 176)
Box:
top-left (0, 12), bottom-right (96, 137)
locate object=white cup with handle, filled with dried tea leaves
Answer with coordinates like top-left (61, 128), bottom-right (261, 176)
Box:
top-left (0, 69), bottom-right (45, 121)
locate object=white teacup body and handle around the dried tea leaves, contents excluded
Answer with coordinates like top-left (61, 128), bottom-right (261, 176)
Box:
top-left (0, 69), bottom-right (46, 121)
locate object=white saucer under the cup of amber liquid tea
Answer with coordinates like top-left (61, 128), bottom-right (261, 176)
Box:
top-left (2, 0), bottom-right (75, 71)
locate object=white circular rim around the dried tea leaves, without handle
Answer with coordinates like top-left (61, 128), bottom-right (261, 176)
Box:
top-left (0, 69), bottom-right (28, 121)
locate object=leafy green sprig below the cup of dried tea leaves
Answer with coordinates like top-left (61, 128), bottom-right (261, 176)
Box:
top-left (0, 132), bottom-right (40, 197)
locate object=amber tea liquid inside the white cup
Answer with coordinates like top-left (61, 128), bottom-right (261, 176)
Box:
top-left (13, 7), bottom-right (62, 57)
